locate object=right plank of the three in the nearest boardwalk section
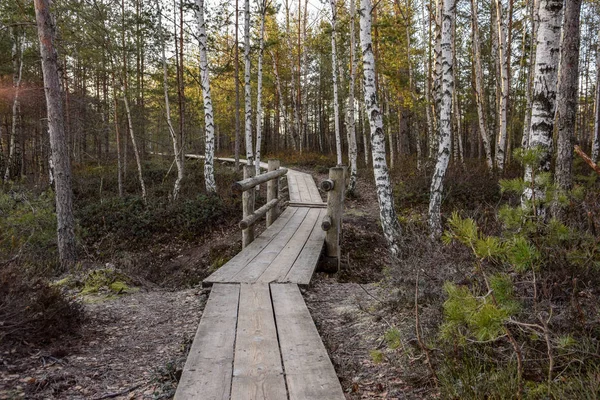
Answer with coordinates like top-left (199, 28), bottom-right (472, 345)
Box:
top-left (271, 283), bottom-right (344, 400)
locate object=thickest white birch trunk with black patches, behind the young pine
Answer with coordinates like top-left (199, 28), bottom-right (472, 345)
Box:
top-left (522, 0), bottom-right (563, 206)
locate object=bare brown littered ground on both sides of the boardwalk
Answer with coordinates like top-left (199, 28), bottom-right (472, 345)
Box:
top-left (0, 167), bottom-right (435, 400)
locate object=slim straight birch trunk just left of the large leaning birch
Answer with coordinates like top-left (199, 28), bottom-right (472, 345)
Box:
top-left (348, 0), bottom-right (358, 193)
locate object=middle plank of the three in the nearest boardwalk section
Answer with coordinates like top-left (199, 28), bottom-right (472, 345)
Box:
top-left (231, 284), bottom-right (287, 400)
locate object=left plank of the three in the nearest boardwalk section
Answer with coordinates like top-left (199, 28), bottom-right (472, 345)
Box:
top-left (175, 285), bottom-right (240, 400)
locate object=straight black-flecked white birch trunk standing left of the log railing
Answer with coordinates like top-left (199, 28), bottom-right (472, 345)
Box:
top-left (196, 0), bottom-right (217, 193)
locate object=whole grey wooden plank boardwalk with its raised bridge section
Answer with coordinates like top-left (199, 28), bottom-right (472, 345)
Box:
top-left (175, 160), bottom-right (345, 400)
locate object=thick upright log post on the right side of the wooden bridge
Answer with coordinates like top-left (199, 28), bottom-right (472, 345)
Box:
top-left (321, 167), bottom-right (345, 272)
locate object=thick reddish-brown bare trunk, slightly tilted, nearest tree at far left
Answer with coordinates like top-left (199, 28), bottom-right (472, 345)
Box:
top-left (34, 0), bottom-right (76, 267)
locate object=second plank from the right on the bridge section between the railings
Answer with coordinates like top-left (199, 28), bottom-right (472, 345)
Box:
top-left (256, 208), bottom-right (321, 283)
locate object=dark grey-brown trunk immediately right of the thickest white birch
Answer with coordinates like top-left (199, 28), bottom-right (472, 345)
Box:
top-left (554, 0), bottom-right (582, 191)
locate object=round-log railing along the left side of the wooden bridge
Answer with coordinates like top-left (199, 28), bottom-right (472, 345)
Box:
top-left (232, 160), bottom-right (287, 247)
